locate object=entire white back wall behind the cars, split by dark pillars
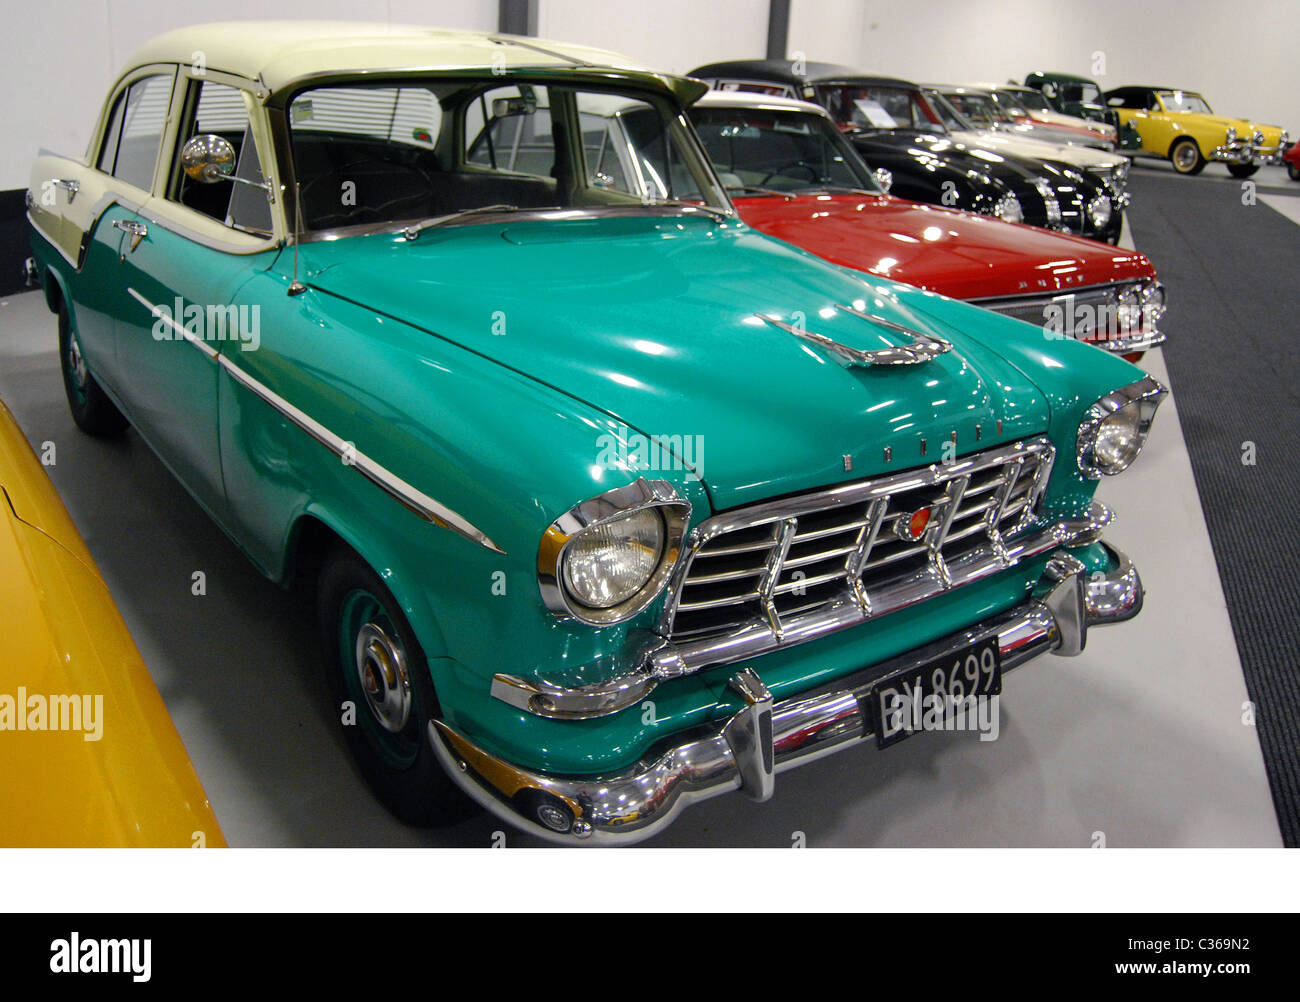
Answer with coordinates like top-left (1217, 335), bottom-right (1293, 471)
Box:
top-left (0, 0), bottom-right (1300, 188)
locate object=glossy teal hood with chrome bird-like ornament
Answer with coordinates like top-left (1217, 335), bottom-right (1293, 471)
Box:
top-left (300, 216), bottom-right (1049, 508)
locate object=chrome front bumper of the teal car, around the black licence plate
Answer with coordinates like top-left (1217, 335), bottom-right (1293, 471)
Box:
top-left (429, 543), bottom-right (1143, 845)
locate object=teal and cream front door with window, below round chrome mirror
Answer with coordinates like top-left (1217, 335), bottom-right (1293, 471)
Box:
top-left (117, 71), bottom-right (278, 519)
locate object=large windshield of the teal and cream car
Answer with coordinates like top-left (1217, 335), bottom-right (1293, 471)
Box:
top-left (289, 77), bottom-right (729, 230)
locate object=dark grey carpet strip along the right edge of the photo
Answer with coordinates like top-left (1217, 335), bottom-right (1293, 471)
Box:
top-left (1128, 168), bottom-right (1300, 846)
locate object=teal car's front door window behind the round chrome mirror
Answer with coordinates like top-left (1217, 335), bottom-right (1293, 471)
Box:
top-left (174, 81), bottom-right (272, 233)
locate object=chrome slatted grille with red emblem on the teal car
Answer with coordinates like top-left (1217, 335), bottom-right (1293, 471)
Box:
top-left (664, 438), bottom-right (1054, 641)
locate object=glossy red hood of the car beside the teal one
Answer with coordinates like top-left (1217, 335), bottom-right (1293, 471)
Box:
top-left (736, 195), bottom-right (1156, 299)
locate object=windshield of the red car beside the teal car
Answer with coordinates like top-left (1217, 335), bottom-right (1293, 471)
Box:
top-left (690, 105), bottom-right (879, 195)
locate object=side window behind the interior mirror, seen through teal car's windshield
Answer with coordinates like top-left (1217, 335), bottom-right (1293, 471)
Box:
top-left (464, 84), bottom-right (555, 179)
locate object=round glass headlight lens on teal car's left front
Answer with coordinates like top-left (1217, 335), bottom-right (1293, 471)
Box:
top-left (563, 508), bottom-right (664, 610)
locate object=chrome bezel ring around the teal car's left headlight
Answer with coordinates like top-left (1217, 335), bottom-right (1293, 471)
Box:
top-left (537, 477), bottom-right (690, 626)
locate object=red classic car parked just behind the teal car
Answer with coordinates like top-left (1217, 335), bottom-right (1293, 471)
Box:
top-left (690, 91), bottom-right (1165, 360)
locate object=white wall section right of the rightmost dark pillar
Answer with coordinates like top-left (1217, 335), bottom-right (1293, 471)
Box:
top-left (789, 0), bottom-right (1300, 138)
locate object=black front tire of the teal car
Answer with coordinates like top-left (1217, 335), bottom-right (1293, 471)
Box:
top-left (316, 545), bottom-right (477, 828)
